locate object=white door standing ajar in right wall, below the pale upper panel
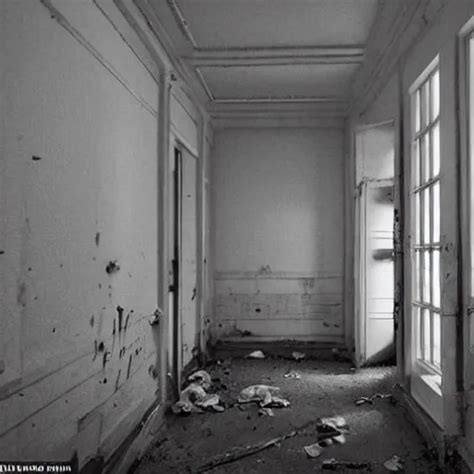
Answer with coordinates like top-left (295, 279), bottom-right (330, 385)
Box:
top-left (356, 179), bottom-right (395, 366)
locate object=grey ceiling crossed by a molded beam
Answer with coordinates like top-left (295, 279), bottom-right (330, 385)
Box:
top-left (139, 0), bottom-right (378, 118)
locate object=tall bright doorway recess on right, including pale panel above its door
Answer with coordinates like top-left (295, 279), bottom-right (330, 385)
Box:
top-left (354, 121), bottom-right (396, 366)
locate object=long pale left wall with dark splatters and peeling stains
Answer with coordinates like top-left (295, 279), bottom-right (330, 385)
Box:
top-left (0, 0), bottom-right (158, 463)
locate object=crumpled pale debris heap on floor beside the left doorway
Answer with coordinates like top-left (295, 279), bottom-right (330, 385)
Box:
top-left (172, 370), bottom-right (224, 415)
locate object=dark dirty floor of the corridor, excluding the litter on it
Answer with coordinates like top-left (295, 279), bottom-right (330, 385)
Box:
top-left (137, 359), bottom-right (441, 474)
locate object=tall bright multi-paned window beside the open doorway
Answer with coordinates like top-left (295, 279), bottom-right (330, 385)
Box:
top-left (411, 61), bottom-right (441, 373)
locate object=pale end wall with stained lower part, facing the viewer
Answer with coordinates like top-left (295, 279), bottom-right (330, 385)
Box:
top-left (212, 128), bottom-right (344, 342)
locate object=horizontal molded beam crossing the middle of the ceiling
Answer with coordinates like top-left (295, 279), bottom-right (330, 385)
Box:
top-left (185, 45), bottom-right (364, 68)
